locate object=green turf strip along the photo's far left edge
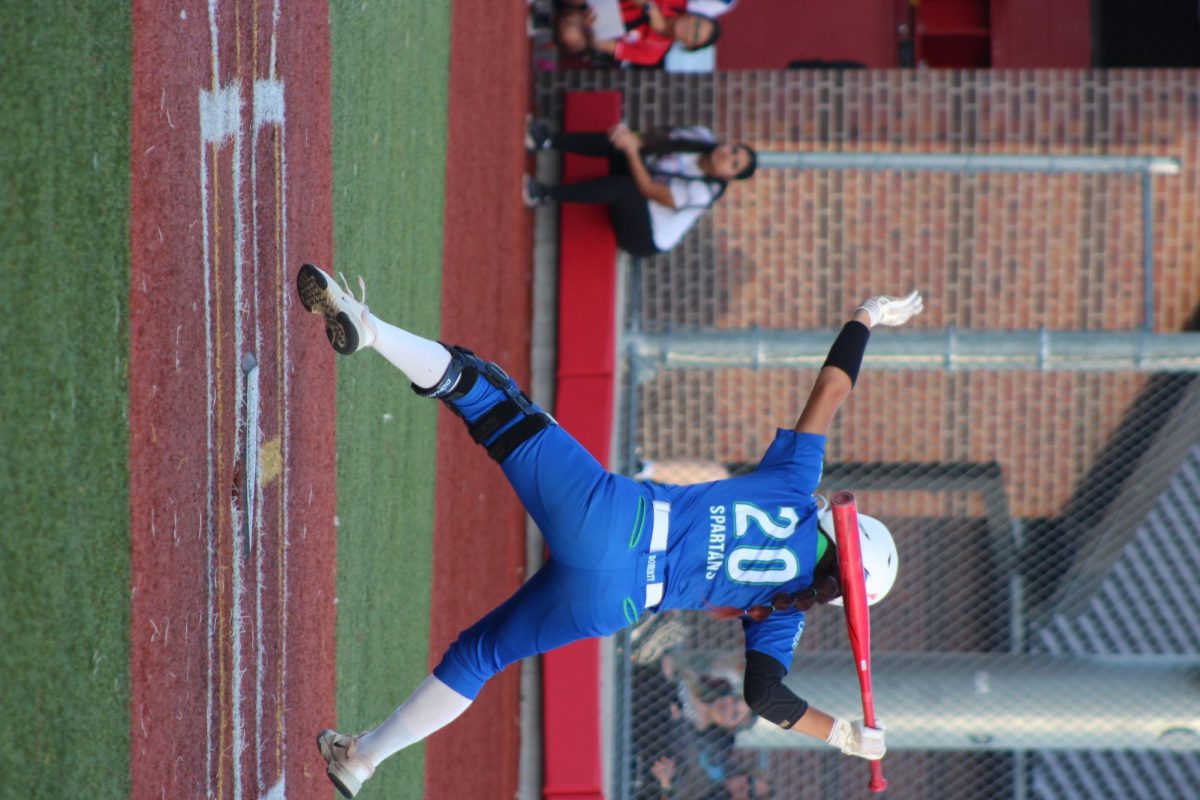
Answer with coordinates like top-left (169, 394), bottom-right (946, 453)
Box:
top-left (0, 2), bottom-right (131, 798)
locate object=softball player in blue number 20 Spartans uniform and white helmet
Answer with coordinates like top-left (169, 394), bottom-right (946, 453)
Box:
top-left (298, 264), bottom-right (922, 798)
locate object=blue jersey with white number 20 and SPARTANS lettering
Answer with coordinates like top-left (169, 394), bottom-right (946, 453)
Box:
top-left (654, 428), bottom-right (826, 667)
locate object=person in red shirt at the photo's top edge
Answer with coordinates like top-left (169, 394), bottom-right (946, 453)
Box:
top-left (557, 0), bottom-right (721, 67)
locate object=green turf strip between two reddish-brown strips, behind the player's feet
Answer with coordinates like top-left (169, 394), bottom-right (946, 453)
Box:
top-left (330, 0), bottom-right (450, 799)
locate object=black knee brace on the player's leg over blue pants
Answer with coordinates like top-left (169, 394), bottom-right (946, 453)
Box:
top-left (413, 345), bottom-right (554, 464)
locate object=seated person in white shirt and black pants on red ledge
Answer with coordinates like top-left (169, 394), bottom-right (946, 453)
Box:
top-left (523, 120), bottom-right (757, 257)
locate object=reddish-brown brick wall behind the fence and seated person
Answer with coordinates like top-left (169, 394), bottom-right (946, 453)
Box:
top-left (538, 71), bottom-right (1200, 517)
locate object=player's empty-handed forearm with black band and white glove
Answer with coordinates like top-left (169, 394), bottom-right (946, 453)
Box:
top-left (796, 289), bottom-right (925, 435)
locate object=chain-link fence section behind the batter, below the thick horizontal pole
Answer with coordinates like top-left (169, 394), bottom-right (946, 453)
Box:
top-left (614, 352), bottom-right (1200, 800)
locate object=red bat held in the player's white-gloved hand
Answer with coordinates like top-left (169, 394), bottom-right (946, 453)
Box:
top-left (832, 492), bottom-right (888, 792)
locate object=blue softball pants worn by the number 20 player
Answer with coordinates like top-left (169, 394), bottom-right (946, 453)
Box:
top-left (433, 377), bottom-right (650, 699)
